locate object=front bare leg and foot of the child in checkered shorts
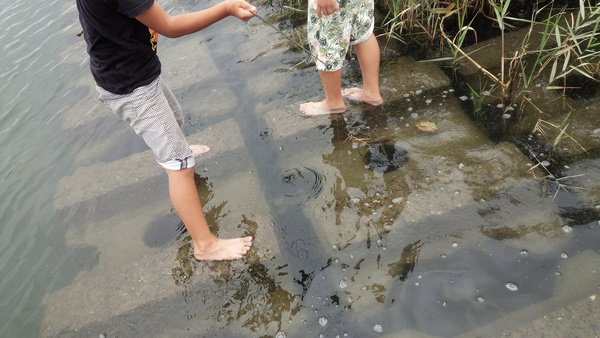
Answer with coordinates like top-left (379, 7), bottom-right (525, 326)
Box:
top-left (166, 168), bottom-right (252, 261)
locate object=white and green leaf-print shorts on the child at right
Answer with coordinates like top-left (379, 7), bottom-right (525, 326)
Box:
top-left (308, 0), bottom-right (375, 71)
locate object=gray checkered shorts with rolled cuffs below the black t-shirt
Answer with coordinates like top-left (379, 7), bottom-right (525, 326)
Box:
top-left (96, 76), bottom-right (195, 170)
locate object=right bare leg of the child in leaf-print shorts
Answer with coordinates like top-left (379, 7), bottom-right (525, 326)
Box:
top-left (342, 33), bottom-right (383, 106)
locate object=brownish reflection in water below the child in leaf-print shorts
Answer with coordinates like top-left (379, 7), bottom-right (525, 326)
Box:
top-left (323, 109), bottom-right (410, 248)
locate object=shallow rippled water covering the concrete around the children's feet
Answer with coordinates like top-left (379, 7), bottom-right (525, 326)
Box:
top-left (0, 1), bottom-right (600, 337)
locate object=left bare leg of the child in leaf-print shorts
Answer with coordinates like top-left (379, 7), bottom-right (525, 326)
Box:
top-left (300, 69), bottom-right (346, 115)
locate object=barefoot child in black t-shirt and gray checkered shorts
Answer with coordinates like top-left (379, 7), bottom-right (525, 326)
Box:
top-left (77, 0), bottom-right (256, 260)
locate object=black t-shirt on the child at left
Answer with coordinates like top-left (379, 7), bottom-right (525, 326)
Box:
top-left (77, 0), bottom-right (160, 94)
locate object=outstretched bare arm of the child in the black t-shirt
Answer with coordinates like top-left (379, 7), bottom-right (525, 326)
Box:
top-left (135, 0), bottom-right (256, 38)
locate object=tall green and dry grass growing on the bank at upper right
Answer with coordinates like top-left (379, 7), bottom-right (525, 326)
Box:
top-left (279, 0), bottom-right (600, 152)
